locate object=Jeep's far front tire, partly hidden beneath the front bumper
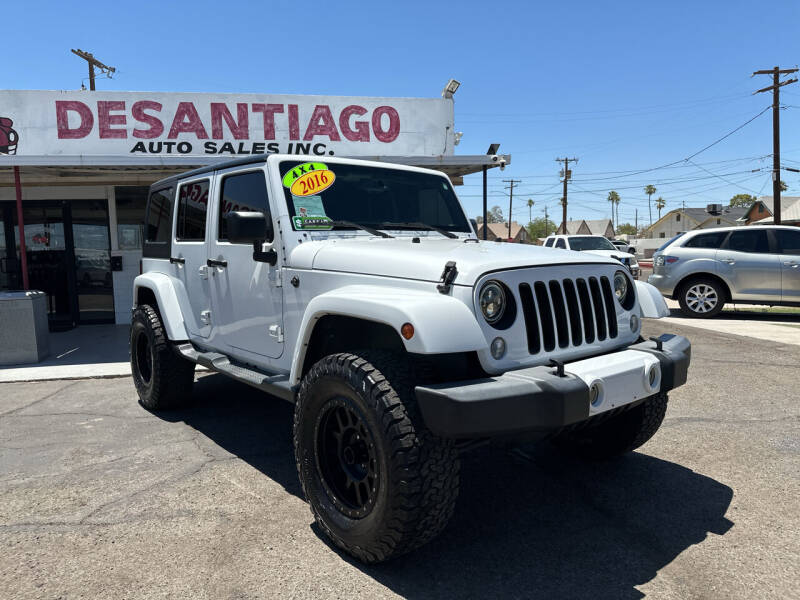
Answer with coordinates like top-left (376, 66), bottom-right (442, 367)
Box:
top-left (553, 392), bottom-right (668, 460)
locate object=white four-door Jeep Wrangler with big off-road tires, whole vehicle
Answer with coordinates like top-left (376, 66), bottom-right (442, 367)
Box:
top-left (130, 155), bottom-right (690, 562)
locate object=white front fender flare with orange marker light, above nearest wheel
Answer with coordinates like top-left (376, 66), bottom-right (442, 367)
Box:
top-left (290, 285), bottom-right (486, 384)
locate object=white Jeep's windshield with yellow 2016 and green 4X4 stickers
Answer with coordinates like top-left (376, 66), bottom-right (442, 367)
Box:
top-left (279, 160), bottom-right (472, 233)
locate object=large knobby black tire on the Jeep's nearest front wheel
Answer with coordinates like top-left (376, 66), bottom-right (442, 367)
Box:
top-left (294, 351), bottom-right (460, 563)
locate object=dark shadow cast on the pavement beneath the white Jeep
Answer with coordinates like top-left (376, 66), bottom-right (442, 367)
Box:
top-left (159, 375), bottom-right (733, 598)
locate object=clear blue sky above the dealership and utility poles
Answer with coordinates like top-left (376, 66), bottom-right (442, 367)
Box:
top-left (0, 0), bottom-right (800, 223)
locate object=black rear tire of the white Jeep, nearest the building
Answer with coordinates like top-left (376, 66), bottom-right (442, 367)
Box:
top-left (129, 304), bottom-right (194, 410)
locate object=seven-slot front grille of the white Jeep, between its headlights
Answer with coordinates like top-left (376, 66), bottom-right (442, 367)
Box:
top-left (519, 276), bottom-right (618, 354)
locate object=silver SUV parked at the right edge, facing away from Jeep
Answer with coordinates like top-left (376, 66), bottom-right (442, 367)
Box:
top-left (647, 225), bottom-right (800, 318)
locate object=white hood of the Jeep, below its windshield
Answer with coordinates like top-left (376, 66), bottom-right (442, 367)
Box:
top-left (288, 236), bottom-right (616, 285)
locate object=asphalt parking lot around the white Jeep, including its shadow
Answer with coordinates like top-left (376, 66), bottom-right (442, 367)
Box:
top-left (0, 322), bottom-right (800, 599)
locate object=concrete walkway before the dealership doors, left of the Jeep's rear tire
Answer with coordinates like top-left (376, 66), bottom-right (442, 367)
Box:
top-left (0, 325), bottom-right (131, 383)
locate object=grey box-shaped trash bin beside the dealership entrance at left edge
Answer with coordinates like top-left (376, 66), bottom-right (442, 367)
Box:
top-left (0, 290), bottom-right (50, 365)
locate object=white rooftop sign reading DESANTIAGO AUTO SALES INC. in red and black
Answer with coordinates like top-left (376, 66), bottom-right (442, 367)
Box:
top-left (0, 90), bottom-right (453, 156)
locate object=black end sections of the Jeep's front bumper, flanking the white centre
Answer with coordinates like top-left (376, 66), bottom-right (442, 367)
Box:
top-left (416, 334), bottom-right (691, 438)
